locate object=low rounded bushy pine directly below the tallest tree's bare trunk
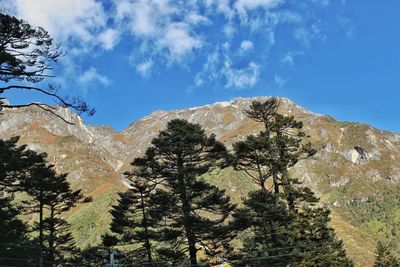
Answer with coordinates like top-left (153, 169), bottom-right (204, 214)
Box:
top-left (230, 190), bottom-right (293, 267)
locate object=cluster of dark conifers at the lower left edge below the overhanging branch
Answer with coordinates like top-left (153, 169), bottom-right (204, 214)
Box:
top-left (0, 137), bottom-right (88, 265)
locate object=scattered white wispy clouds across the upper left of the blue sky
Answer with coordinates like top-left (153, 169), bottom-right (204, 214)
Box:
top-left (0, 0), bottom-right (352, 89)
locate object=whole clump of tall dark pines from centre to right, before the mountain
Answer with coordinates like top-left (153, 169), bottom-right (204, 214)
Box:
top-left (97, 98), bottom-right (353, 266)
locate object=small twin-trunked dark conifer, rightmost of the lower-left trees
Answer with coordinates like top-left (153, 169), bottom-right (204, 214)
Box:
top-left (22, 154), bottom-right (86, 264)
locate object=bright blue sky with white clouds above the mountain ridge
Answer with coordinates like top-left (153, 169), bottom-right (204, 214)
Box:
top-left (0, 0), bottom-right (400, 133)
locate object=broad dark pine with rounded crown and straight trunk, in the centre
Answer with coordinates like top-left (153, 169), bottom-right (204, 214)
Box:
top-left (132, 119), bottom-right (235, 266)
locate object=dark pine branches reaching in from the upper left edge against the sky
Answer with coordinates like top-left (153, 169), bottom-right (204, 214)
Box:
top-left (0, 13), bottom-right (95, 121)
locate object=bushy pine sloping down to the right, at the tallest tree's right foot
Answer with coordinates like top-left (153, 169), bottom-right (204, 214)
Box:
top-left (284, 179), bottom-right (353, 267)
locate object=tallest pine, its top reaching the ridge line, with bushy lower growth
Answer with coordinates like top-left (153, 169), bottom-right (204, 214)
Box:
top-left (233, 98), bottom-right (352, 266)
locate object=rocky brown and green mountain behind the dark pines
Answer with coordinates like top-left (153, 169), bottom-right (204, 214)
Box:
top-left (0, 97), bottom-right (400, 266)
